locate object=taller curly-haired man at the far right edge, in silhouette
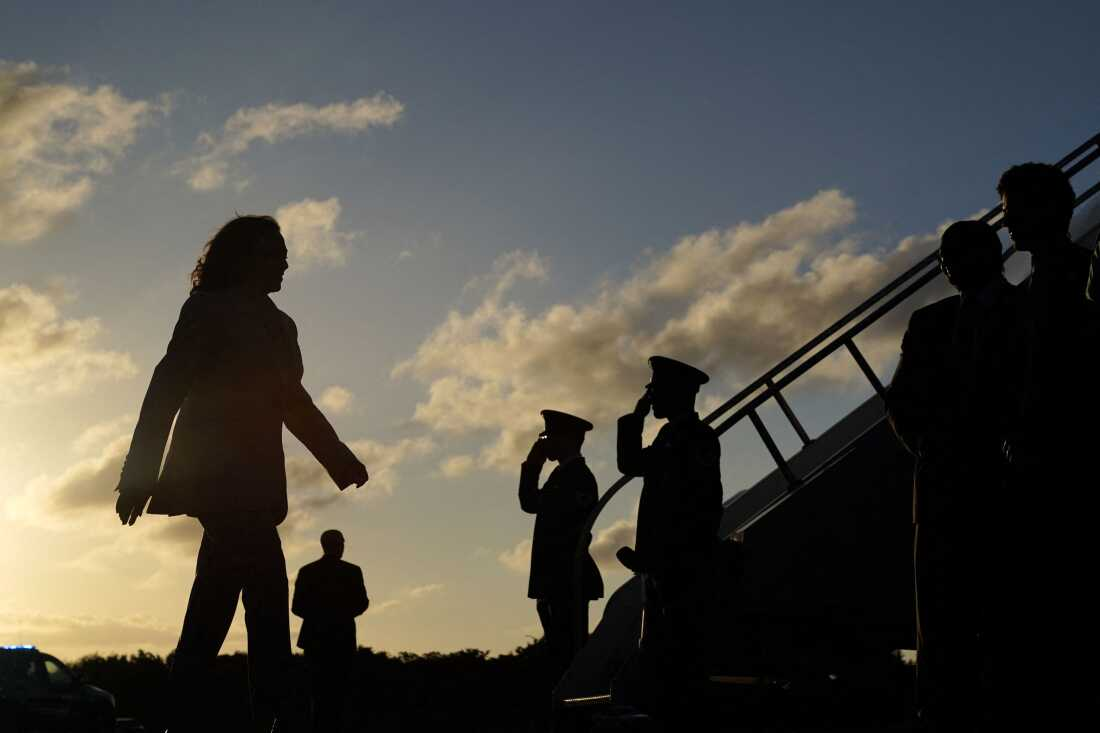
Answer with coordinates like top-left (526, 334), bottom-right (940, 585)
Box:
top-left (997, 163), bottom-right (1100, 725)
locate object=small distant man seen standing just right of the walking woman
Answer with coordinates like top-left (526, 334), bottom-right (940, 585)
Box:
top-left (290, 529), bottom-right (371, 733)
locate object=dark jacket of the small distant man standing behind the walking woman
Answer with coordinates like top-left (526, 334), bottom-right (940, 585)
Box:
top-left (290, 557), bottom-right (371, 653)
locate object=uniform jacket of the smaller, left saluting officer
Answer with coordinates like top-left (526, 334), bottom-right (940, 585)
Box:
top-left (519, 456), bottom-right (604, 600)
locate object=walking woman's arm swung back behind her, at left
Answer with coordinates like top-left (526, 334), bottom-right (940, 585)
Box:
top-left (114, 295), bottom-right (211, 525)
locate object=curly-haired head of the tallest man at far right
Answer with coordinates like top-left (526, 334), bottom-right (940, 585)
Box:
top-left (997, 163), bottom-right (1077, 253)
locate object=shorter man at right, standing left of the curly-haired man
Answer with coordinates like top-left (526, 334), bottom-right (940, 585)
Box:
top-left (887, 221), bottom-right (1020, 731)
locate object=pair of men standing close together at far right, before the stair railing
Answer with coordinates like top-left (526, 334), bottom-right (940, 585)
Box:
top-left (886, 163), bottom-right (1100, 731)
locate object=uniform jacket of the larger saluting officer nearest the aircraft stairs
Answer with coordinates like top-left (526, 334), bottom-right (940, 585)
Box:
top-left (617, 413), bottom-right (722, 576)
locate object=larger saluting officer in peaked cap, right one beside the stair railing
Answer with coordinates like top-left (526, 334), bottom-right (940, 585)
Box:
top-left (617, 357), bottom-right (722, 717)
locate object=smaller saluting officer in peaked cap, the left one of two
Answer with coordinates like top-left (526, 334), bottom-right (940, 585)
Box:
top-left (519, 409), bottom-right (604, 686)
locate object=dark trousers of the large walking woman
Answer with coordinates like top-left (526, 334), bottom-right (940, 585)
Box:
top-left (169, 516), bottom-right (290, 733)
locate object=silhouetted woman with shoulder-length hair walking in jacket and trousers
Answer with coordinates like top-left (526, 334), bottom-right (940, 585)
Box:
top-left (116, 216), bottom-right (367, 733)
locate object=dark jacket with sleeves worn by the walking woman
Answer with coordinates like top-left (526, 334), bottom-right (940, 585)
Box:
top-left (119, 292), bottom-right (355, 524)
